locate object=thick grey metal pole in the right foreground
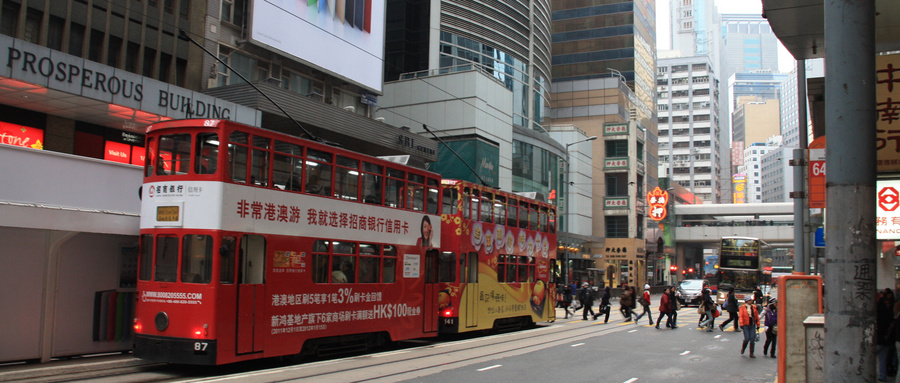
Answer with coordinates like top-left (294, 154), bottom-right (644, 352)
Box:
top-left (823, 0), bottom-right (878, 382)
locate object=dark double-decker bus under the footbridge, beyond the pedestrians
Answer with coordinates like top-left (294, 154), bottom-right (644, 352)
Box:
top-left (716, 237), bottom-right (772, 303)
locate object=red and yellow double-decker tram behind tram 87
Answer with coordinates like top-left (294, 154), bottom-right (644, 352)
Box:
top-left (438, 179), bottom-right (559, 333)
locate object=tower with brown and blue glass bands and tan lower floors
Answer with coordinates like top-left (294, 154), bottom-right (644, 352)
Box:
top-left (551, 1), bottom-right (658, 286)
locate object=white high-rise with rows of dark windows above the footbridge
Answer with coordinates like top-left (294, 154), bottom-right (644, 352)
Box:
top-left (656, 56), bottom-right (721, 202)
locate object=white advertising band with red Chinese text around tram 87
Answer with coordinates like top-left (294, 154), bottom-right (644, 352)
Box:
top-left (141, 181), bottom-right (441, 247)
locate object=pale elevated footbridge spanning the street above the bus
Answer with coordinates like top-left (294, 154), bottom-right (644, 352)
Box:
top-left (673, 202), bottom-right (794, 247)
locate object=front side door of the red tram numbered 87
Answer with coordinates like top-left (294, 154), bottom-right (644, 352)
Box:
top-left (236, 235), bottom-right (266, 354)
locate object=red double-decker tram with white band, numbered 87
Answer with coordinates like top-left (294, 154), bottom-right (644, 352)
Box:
top-left (134, 120), bottom-right (442, 365)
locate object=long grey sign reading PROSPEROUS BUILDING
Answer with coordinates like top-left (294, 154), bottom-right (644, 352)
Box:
top-left (0, 36), bottom-right (261, 133)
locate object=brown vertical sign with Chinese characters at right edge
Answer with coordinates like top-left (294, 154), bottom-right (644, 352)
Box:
top-left (875, 55), bottom-right (900, 173)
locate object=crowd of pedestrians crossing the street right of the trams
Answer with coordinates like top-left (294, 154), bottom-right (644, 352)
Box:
top-left (557, 282), bottom-right (772, 360)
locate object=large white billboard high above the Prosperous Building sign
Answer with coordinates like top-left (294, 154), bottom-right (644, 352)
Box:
top-left (250, 0), bottom-right (385, 93)
